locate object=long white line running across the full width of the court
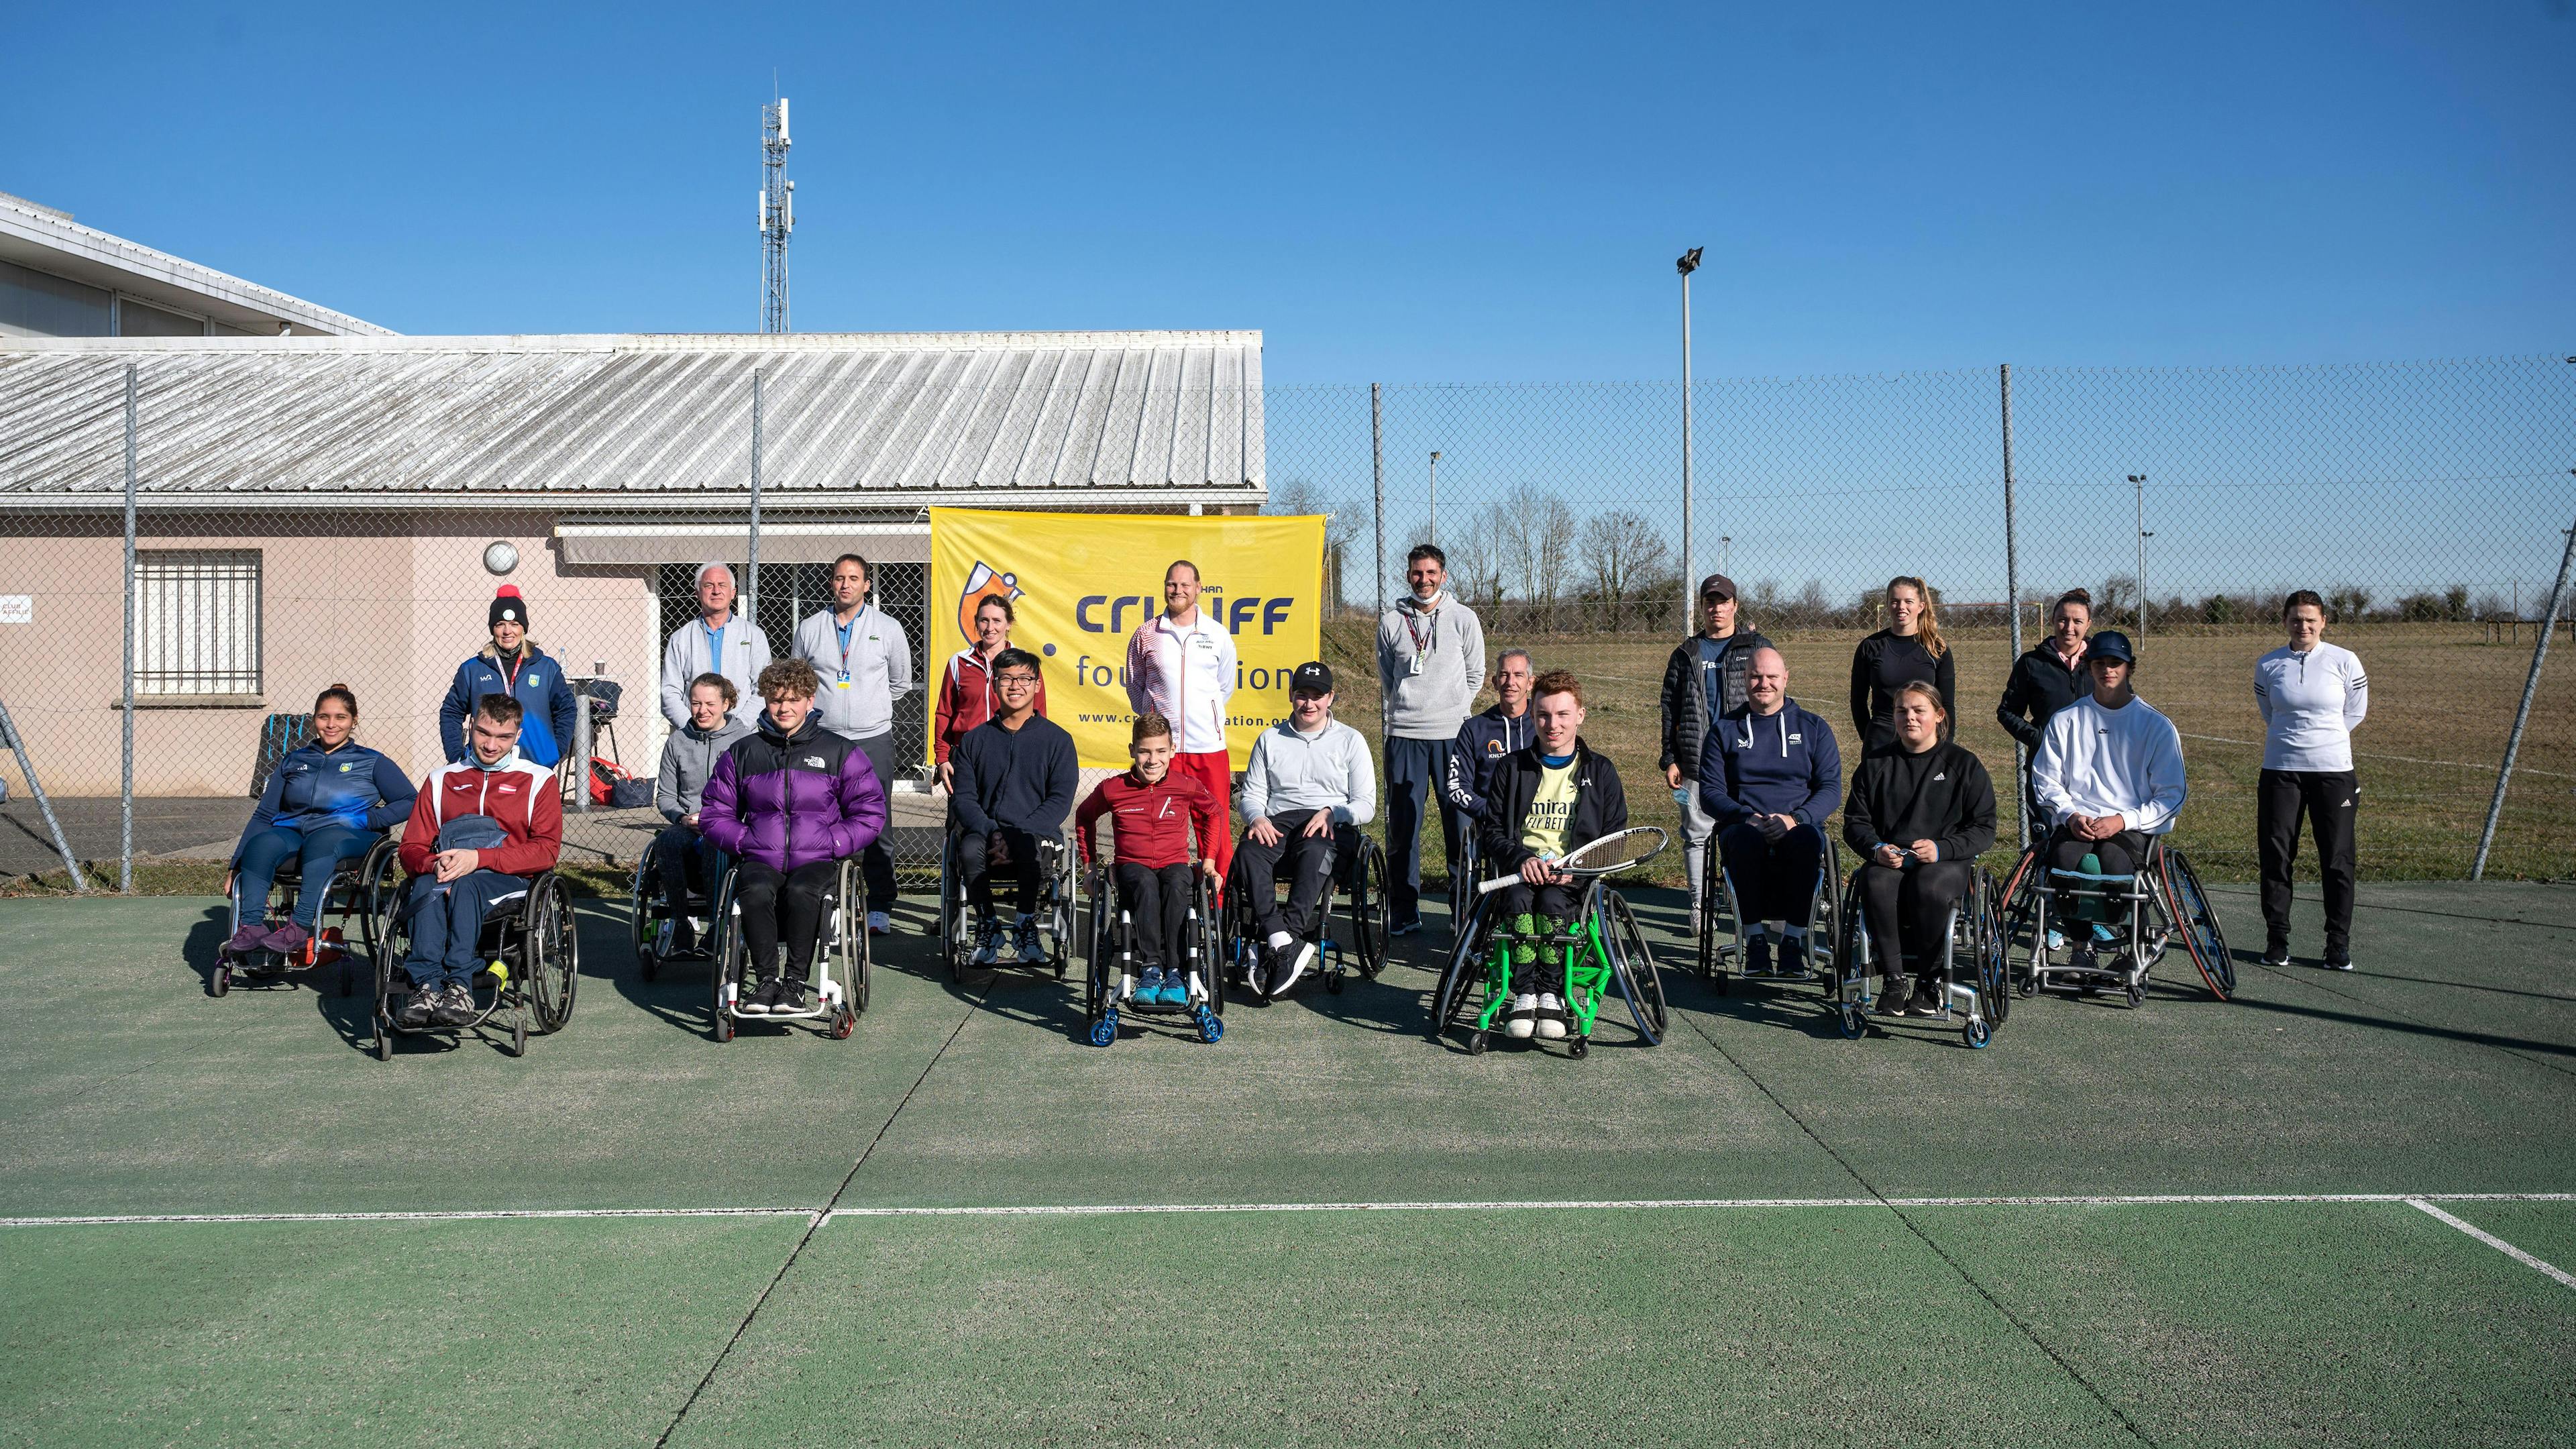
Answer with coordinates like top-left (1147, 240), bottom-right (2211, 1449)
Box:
top-left (0, 1191), bottom-right (2576, 1232)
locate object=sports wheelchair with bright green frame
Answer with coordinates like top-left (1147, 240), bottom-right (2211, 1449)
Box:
top-left (1430, 861), bottom-right (1669, 1057)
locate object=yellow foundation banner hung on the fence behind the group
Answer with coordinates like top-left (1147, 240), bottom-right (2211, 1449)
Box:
top-left (925, 508), bottom-right (1324, 768)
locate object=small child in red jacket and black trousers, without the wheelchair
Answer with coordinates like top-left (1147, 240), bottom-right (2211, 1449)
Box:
top-left (1074, 712), bottom-right (1226, 1006)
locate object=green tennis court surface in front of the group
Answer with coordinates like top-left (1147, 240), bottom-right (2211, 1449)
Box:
top-left (0, 884), bottom-right (2576, 1446)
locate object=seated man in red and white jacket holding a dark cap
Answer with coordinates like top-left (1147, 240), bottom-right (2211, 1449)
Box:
top-left (399, 694), bottom-right (564, 1029)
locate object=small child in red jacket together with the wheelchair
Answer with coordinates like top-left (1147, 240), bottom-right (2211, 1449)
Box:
top-left (1074, 712), bottom-right (1226, 1044)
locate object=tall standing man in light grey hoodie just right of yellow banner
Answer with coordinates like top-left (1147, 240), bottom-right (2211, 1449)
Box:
top-left (1378, 544), bottom-right (1484, 936)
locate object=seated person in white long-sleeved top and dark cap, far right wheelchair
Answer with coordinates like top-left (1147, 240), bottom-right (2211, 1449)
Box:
top-left (2030, 629), bottom-right (2184, 877)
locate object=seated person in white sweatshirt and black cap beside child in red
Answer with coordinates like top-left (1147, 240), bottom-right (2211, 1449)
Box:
top-left (1234, 663), bottom-right (1378, 996)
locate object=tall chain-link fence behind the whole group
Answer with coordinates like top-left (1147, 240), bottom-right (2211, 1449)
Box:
top-left (0, 351), bottom-right (2576, 879)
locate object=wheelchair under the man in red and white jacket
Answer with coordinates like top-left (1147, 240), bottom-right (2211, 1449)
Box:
top-left (368, 871), bottom-right (582, 1062)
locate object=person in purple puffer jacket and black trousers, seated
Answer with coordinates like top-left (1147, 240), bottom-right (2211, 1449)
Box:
top-left (698, 660), bottom-right (886, 1016)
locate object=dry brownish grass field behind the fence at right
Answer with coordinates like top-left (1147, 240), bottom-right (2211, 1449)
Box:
top-left (1324, 610), bottom-right (2576, 884)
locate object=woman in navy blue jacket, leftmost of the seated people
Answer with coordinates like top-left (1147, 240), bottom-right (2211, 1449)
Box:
top-left (224, 684), bottom-right (417, 957)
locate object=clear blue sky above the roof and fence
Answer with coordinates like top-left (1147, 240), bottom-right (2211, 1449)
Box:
top-left (0, 0), bottom-right (2576, 382)
